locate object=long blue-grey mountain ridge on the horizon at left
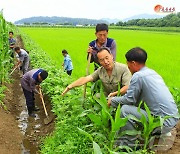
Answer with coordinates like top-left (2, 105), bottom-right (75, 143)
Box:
top-left (14, 16), bottom-right (108, 25)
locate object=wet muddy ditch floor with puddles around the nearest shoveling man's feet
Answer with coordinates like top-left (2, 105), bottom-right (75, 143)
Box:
top-left (16, 85), bottom-right (54, 154)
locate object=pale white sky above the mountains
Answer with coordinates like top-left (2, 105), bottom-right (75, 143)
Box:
top-left (0, 0), bottom-right (180, 22)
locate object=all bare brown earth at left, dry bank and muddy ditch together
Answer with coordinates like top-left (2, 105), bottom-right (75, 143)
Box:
top-left (0, 36), bottom-right (54, 154)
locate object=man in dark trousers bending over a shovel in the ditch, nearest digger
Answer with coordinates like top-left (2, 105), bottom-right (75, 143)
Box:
top-left (21, 69), bottom-right (48, 117)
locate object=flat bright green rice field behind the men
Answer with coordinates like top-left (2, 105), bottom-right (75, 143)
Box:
top-left (20, 28), bottom-right (180, 87)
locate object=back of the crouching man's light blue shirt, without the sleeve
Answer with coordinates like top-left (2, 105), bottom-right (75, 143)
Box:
top-left (132, 67), bottom-right (178, 116)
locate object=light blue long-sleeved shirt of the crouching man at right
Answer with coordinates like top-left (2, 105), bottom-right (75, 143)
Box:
top-left (111, 67), bottom-right (178, 125)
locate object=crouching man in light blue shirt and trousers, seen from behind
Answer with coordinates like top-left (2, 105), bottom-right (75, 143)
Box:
top-left (108, 47), bottom-right (178, 150)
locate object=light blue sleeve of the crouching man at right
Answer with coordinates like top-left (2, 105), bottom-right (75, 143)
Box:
top-left (111, 75), bottom-right (142, 108)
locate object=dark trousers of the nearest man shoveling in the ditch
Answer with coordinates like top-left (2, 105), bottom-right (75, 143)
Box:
top-left (22, 88), bottom-right (35, 114)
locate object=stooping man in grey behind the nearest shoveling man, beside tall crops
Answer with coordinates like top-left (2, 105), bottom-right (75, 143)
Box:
top-left (14, 47), bottom-right (29, 74)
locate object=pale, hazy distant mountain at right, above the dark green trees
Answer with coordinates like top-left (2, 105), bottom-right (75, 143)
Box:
top-left (122, 14), bottom-right (165, 22)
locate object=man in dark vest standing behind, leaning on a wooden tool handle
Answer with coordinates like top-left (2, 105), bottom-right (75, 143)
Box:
top-left (87, 23), bottom-right (116, 70)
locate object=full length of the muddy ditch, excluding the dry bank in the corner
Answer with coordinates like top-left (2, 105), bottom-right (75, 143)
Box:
top-left (12, 35), bottom-right (54, 154)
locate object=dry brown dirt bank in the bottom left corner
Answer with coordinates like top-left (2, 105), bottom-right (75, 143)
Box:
top-left (0, 81), bottom-right (23, 154)
